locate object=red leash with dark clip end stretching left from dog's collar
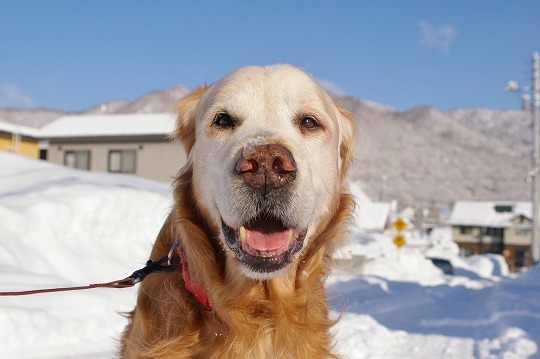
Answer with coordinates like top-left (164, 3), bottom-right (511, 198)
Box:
top-left (0, 242), bottom-right (180, 297)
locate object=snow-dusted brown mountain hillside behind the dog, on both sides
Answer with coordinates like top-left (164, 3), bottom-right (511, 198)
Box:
top-left (0, 86), bottom-right (531, 209)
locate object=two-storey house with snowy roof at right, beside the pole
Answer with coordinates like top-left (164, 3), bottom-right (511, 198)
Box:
top-left (448, 201), bottom-right (532, 270)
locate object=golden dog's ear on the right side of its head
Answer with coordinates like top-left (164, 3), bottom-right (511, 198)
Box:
top-left (334, 101), bottom-right (356, 181)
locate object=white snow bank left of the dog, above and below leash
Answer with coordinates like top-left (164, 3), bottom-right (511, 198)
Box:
top-left (0, 152), bottom-right (170, 358)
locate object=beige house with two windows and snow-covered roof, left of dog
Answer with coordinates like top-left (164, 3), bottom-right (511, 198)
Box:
top-left (37, 114), bottom-right (186, 181)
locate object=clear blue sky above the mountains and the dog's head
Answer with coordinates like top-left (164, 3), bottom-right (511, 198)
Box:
top-left (0, 0), bottom-right (540, 110)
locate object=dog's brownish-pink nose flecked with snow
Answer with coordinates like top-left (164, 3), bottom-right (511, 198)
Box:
top-left (236, 144), bottom-right (296, 191)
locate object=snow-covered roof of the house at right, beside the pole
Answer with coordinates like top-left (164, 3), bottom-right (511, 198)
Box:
top-left (448, 201), bottom-right (532, 228)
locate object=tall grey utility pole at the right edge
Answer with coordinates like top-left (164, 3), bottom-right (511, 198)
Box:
top-left (506, 52), bottom-right (540, 264)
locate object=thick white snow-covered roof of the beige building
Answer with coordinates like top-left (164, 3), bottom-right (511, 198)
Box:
top-left (39, 113), bottom-right (175, 139)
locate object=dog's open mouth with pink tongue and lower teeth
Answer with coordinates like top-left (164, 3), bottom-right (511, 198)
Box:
top-left (221, 217), bottom-right (307, 273)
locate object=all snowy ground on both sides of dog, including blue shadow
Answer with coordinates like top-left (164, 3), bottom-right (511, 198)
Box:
top-left (0, 152), bottom-right (540, 359)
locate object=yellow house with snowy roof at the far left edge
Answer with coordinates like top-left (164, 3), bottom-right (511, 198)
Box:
top-left (0, 121), bottom-right (39, 159)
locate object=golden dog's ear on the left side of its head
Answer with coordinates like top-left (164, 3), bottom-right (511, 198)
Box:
top-left (170, 85), bottom-right (208, 155)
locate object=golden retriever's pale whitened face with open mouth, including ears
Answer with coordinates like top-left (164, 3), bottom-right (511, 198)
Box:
top-left (176, 65), bottom-right (354, 279)
